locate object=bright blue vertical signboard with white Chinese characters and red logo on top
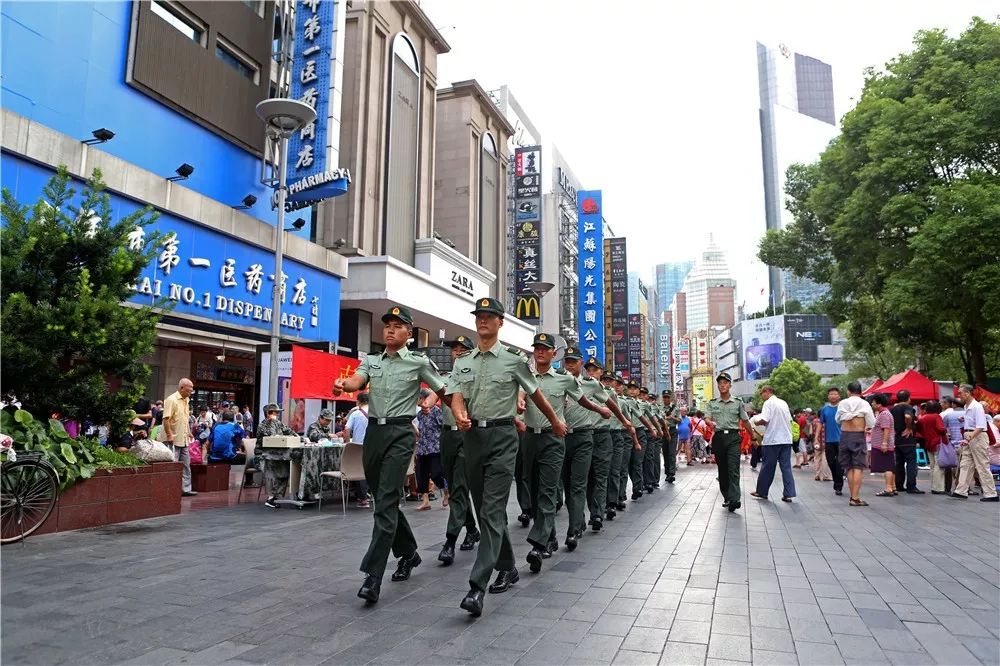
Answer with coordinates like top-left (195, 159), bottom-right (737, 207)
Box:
top-left (576, 190), bottom-right (604, 363)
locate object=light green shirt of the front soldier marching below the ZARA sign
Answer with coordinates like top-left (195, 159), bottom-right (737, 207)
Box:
top-left (447, 342), bottom-right (538, 418)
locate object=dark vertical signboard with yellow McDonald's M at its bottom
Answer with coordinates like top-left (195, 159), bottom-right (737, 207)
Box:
top-left (514, 146), bottom-right (542, 325)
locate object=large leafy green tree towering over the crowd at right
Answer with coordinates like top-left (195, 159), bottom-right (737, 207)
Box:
top-left (759, 18), bottom-right (1000, 384)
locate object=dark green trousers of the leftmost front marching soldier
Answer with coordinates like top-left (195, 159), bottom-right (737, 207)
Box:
top-left (361, 426), bottom-right (417, 577)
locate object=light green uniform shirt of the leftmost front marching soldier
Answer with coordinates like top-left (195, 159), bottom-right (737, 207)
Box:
top-left (356, 347), bottom-right (444, 419)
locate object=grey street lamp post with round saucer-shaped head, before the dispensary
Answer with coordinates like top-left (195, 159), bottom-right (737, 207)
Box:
top-left (257, 98), bottom-right (316, 403)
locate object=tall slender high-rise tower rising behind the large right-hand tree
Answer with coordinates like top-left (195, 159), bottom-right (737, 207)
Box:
top-left (757, 42), bottom-right (838, 304)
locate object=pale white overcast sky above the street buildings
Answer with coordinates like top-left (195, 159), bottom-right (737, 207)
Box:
top-left (420, 0), bottom-right (1000, 310)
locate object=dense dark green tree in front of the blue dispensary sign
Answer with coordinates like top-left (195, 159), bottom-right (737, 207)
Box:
top-left (0, 167), bottom-right (158, 424)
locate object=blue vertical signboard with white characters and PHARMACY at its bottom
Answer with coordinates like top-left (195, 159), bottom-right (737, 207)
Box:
top-left (287, 0), bottom-right (350, 208)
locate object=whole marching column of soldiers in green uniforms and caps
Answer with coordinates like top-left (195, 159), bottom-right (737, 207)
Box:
top-left (333, 298), bottom-right (739, 617)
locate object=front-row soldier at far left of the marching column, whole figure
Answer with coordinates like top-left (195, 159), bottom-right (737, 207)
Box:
top-left (333, 305), bottom-right (444, 603)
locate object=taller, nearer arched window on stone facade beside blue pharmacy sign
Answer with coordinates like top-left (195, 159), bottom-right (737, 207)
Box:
top-left (382, 33), bottom-right (420, 265)
